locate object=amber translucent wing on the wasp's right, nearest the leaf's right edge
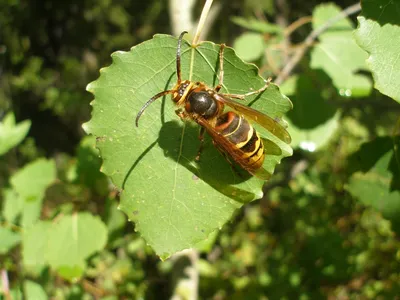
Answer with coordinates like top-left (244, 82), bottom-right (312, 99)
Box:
top-left (213, 93), bottom-right (292, 144)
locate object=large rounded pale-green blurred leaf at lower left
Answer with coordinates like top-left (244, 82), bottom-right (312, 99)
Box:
top-left (45, 213), bottom-right (107, 280)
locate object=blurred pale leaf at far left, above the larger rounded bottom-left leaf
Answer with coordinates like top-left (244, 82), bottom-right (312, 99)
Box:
top-left (8, 158), bottom-right (56, 227)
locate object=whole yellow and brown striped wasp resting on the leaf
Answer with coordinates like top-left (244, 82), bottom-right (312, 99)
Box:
top-left (136, 31), bottom-right (291, 180)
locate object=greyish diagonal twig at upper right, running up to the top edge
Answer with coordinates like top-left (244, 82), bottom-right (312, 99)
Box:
top-left (275, 3), bottom-right (361, 85)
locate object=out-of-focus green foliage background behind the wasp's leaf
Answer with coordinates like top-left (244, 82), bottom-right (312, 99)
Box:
top-left (0, 0), bottom-right (400, 299)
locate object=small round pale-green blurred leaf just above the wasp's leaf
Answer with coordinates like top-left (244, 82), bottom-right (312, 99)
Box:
top-left (233, 32), bottom-right (265, 61)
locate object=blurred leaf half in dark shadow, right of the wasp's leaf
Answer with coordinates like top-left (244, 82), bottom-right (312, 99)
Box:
top-left (281, 75), bottom-right (340, 152)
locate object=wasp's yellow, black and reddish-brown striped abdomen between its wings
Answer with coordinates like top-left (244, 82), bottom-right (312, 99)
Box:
top-left (215, 111), bottom-right (265, 172)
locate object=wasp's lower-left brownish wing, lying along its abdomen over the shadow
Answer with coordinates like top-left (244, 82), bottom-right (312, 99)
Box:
top-left (196, 118), bottom-right (271, 180)
